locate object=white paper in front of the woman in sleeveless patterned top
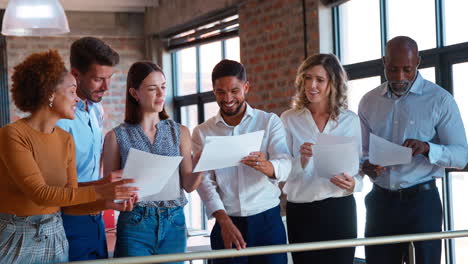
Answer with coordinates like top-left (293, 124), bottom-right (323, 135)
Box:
top-left (123, 148), bottom-right (182, 201)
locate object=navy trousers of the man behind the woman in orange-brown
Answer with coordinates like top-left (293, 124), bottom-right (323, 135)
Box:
top-left (62, 214), bottom-right (108, 261)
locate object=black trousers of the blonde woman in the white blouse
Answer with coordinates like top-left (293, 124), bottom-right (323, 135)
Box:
top-left (286, 195), bottom-right (357, 264)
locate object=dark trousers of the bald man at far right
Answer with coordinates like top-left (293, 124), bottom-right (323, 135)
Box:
top-left (365, 185), bottom-right (442, 264)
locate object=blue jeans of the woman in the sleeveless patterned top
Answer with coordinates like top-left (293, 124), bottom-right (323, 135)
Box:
top-left (114, 206), bottom-right (187, 264)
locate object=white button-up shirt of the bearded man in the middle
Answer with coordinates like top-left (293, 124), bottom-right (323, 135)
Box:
top-left (192, 105), bottom-right (291, 217)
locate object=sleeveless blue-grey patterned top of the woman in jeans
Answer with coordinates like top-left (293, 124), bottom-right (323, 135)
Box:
top-left (114, 119), bottom-right (187, 208)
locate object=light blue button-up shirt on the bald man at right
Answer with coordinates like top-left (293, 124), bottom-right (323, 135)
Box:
top-left (359, 73), bottom-right (468, 190)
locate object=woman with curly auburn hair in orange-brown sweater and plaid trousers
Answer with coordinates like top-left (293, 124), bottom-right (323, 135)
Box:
top-left (0, 51), bottom-right (136, 263)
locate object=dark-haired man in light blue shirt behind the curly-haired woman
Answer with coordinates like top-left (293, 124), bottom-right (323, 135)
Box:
top-left (58, 37), bottom-right (119, 261)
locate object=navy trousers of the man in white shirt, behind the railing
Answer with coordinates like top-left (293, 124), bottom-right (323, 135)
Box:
top-left (211, 206), bottom-right (288, 264)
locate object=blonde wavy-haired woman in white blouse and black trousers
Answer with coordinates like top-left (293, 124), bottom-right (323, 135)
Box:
top-left (281, 54), bottom-right (362, 264)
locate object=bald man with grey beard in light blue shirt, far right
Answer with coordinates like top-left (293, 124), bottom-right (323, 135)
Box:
top-left (359, 36), bottom-right (468, 264)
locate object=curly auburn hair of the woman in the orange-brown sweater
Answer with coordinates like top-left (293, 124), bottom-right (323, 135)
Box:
top-left (11, 50), bottom-right (68, 113)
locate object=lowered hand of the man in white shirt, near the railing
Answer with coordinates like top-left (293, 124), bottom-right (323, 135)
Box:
top-left (213, 210), bottom-right (247, 250)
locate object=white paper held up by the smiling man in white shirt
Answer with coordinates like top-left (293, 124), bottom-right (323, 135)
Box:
top-left (193, 130), bottom-right (265, 172)
